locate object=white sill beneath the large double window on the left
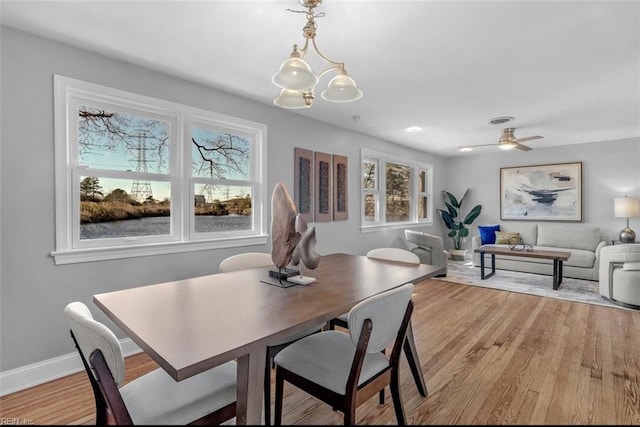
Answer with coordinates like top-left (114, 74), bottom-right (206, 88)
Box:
top-left (51, 235), bottom-right (268, 265)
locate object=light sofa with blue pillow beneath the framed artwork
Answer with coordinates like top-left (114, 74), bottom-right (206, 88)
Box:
top-left (471, 222), bottom-right (606, 280)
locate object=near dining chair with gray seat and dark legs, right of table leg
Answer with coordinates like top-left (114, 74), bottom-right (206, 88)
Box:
top-left (274, 283), bottom-right (414, 425)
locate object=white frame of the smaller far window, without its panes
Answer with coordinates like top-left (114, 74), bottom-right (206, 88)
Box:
top-left (359, 148), bottom-right (434, 233)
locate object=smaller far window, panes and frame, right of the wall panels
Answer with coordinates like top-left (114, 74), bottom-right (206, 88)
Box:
top-left (361, 149), bottom-right (433, 230)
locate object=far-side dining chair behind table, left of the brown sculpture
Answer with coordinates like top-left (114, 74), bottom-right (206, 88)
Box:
top-left (219, 252), bottom-right (326, 425)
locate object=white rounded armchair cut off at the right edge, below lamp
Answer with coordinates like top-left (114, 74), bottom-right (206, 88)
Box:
top-left (599, 244), bottom-right (640, 309)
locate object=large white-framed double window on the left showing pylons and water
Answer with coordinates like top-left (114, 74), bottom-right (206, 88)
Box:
top-left (52, 76), bottom-right (266, 264)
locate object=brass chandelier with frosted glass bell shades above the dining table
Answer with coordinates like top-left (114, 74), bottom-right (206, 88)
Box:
top-left (271, 0), bottom-right (363, 109)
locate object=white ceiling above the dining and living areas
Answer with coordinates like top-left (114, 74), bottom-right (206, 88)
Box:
top-left (0, 0), bottom-right (640, 157)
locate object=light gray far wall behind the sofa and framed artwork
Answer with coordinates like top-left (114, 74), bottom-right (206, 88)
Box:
top-left (446, 138), bottom-right (640, 248)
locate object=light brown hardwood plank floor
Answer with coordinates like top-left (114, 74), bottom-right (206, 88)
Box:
top-left (0, 280), bottom-right (640, 425)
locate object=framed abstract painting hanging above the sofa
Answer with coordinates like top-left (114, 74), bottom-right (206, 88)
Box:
top-left (500, 162), bottom-right (582, 221)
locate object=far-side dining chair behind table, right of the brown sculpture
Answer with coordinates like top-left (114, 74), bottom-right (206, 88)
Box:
top-left (327, 248), bottom-right (428, 404)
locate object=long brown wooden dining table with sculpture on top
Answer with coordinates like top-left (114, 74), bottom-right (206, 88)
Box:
top-left (93, 253), bottom-right (443, 424)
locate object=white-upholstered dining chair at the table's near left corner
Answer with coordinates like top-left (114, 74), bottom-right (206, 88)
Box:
top-left (64, 301), bottom-right (236, 425)
